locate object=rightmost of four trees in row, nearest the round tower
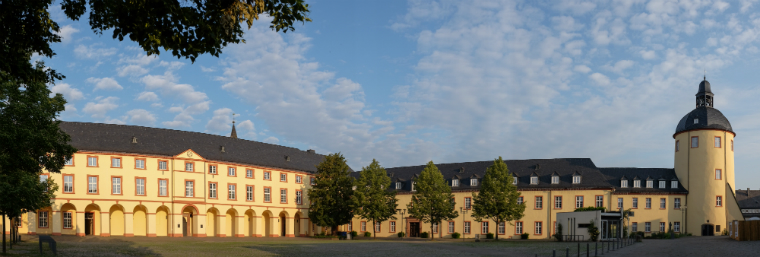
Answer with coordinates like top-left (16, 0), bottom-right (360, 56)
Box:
top-left (472, 156), bottom-right (525, 240)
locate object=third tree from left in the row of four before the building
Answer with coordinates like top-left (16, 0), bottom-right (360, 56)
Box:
top-left (407, 161), bottom-right (459, 240)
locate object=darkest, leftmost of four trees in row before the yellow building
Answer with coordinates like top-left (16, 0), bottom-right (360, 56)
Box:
top-left (307, 153), bottom-right (354, 233)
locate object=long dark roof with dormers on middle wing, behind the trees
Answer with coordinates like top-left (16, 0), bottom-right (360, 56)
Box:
top-left (360, 158), bottom-right (612, 192)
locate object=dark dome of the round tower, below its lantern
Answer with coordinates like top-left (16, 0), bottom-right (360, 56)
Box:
top-left (673, 106), bottom-right (736, 137)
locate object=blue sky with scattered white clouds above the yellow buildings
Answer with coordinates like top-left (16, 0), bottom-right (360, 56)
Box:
top-left (44, 0), bottom-right (760, 189)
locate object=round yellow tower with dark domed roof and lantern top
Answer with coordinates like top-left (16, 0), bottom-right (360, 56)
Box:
top-left (673, 79), bottom-right (738, 236)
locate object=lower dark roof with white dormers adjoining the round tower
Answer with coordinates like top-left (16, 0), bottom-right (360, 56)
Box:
top-left (599, 168), bottom-right (688, 194)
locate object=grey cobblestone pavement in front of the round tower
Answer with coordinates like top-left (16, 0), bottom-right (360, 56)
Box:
top-left (608, 236), bottom-right (760, 257)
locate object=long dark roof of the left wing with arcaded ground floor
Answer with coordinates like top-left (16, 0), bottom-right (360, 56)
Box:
top-left (60, 122), bottom-right (332, 172)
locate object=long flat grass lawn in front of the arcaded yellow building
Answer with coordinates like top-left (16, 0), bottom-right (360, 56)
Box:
top-left (0, 236), bottom-right (628, 257)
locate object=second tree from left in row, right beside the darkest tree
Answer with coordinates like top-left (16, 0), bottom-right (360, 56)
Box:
top-left (353, 159), bottom-right (398, 237)
